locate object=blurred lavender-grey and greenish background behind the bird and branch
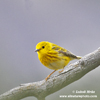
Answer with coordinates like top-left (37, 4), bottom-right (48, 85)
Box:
top-left (0, 0), bottom-right (100, 100)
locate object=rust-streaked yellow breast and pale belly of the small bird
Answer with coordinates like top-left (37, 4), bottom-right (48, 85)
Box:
top-left (38, 52), bottom-right (70, 70)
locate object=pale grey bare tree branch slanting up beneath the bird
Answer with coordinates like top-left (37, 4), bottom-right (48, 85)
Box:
top-left (0, 48), bottom-right (100, 100)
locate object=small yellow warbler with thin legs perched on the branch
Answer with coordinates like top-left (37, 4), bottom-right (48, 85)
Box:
top-left (35, 41), bottom-right (81, 80)
